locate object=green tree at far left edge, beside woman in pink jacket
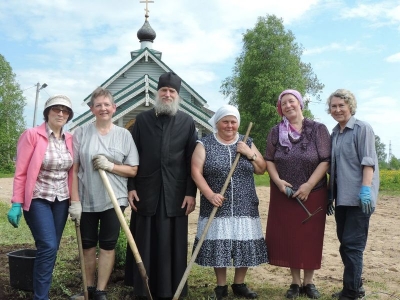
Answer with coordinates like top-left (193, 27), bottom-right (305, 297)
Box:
top-left (0, 54), bottom-right (26, 172)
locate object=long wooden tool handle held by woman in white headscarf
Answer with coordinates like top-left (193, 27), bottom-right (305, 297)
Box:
top-left (172, 122), bottom-right (253, 300)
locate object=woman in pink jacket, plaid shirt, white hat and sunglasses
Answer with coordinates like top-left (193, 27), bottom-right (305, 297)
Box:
top-left (8, 95), bottom-right (82, 300)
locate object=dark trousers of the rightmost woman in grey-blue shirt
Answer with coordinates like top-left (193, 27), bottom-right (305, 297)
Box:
top-left (335, 206), bottom-right (371, 299)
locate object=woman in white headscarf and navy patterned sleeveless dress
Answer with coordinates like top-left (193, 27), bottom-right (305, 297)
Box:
top-left (192, 105), bottom-right (268, 299)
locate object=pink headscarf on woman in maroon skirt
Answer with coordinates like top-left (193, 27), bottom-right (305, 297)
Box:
top-left (276, 90), bottom-right (304, 149)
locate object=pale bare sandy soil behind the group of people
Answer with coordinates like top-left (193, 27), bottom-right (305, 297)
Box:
top-left (0, 178), bottom-right (400, 299)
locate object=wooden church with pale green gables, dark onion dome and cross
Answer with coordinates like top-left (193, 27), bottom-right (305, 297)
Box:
top-left (70, 0), bottom-right (214, 137)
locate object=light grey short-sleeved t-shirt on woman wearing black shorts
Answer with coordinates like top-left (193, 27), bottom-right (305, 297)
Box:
top-left (73, 123), bottom-right (139, 212)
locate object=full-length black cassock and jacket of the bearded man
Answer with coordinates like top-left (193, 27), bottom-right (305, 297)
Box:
top-left (125, 109), bottom-right (197, 298)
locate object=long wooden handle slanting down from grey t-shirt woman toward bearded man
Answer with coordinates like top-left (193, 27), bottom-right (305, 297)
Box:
top-left (98, 169), bottom-right (153, 300)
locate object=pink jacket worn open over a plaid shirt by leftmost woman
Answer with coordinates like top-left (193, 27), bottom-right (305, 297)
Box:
top-left (11, 123), bottom-right (73, 211)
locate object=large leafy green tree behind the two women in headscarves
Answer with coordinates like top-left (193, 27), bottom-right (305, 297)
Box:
top-left (221, 15), bottom-right (324, 153)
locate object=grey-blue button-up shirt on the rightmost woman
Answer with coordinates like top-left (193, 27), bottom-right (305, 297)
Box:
top-left (330, 116), bottom-right (379, 207)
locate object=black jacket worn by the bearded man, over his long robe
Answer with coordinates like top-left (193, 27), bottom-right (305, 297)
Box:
top-left (128, 109), bottom-right (197, 217)
